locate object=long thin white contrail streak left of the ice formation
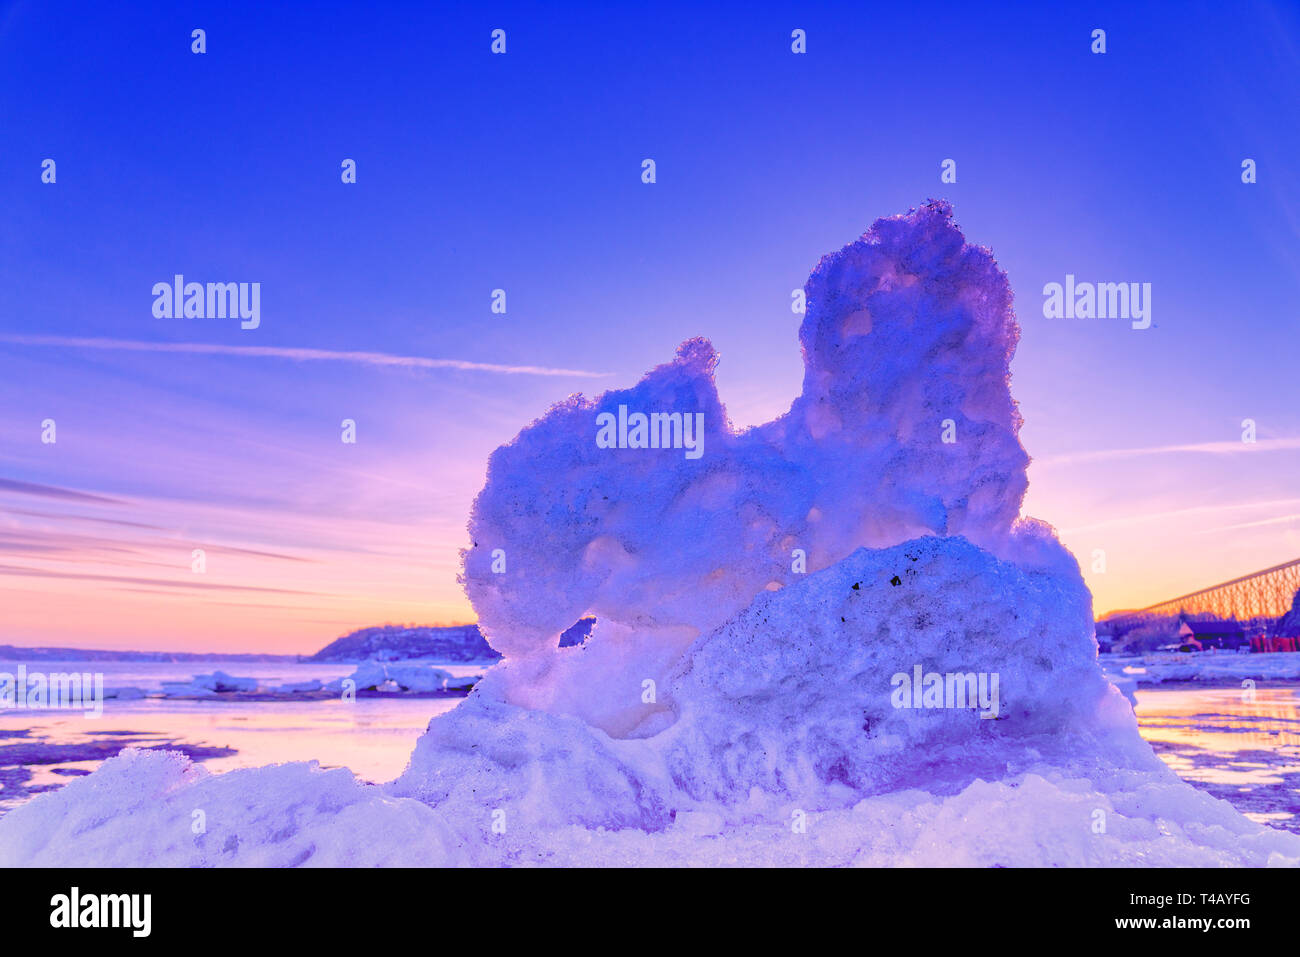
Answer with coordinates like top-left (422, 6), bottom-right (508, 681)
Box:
top-left (0, 334), bottom-right (614, 378)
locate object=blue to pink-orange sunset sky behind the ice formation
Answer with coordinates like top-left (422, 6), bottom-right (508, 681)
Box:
top-left (0, 1), bottom-right (1300, 653)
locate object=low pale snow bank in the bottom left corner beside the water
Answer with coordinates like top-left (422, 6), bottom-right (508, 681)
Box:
top-left (0, 748), bottom-right (456, 867)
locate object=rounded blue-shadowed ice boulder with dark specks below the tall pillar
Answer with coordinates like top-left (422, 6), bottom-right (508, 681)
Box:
top-left (663, 537), bottom-right (1123, 809)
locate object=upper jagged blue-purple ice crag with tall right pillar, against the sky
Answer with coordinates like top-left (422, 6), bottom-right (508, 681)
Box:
top-left (464, 203), bottom-right (1028, 700)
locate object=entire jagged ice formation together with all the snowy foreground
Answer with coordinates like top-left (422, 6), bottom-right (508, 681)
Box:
top-left (0, 203), bottom-right (1300, 866)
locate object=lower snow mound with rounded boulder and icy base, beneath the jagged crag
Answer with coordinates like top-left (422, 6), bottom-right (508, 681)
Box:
top-left (391, 527), bottom-right (1300, 866)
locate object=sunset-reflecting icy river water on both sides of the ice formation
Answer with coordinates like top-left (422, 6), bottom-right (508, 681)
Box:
top-left (0, 662), bottom-right (1300, 832)
